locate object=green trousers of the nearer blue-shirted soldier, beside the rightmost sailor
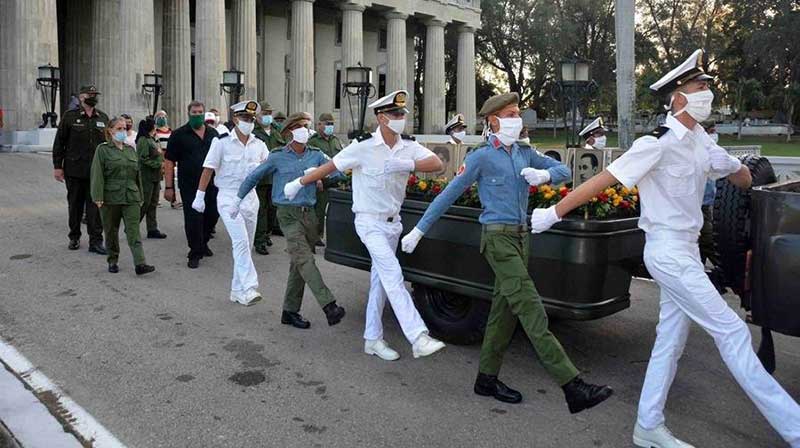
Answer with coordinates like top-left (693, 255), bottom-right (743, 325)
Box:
top-left (479, 225), bottom-right (578, 386)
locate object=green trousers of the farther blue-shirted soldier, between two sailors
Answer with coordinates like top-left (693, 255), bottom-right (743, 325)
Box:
top-left (277, 205), bottom-right (335, 313)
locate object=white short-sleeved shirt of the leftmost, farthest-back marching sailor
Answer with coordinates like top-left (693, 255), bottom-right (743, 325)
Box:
top-left (203, 132), bottom-right (269, 190)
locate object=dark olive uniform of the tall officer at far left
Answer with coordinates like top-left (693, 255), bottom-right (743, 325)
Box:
top-left (53, 104), bottom-right (108, 245)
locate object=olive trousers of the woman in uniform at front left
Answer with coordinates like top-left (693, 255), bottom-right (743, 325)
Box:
top-left (100, 204), bottom-right (145, 266)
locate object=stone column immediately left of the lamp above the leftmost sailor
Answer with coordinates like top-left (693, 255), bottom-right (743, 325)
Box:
top-left (194, 0), bottom-right (227, 117)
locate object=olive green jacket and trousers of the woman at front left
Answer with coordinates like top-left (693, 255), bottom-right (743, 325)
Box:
top-left (91, 143), bottom-right (145, 266)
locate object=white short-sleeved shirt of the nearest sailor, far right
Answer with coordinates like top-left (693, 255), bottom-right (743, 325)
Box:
top-left (608, 114), bottom-right (730, 235)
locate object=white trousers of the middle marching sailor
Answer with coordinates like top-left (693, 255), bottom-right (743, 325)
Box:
top-left (355, 214), bottom-right (428, 344)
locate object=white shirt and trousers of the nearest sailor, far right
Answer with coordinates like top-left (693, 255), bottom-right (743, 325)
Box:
top-left (608, 115), bottom-right (800, 448)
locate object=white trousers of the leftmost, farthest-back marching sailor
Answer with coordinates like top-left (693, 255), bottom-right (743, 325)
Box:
top-left (217, 189), bottom-right (258, 296)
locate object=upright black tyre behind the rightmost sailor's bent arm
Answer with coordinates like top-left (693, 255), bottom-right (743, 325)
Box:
top-left (714, 155), bottom-right (777, 300)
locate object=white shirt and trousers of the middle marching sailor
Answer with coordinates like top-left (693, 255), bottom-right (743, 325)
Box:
top-left (333, 131), bottom-right (436, 344)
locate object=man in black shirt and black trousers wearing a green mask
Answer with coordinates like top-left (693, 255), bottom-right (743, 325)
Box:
top-left (164, 101), bottom-right (219, 269)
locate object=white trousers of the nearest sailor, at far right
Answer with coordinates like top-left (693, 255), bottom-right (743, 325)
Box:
top-left (638, 235), bottom-right (800, 448)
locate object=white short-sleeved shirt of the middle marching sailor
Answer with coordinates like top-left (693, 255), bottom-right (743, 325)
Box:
top-left (333, 130), bottom-right (436, 218)
